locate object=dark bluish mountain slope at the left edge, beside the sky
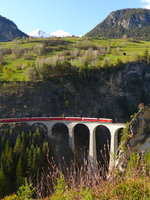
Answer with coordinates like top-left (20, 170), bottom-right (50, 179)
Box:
top-left (0, 16), bottom-right (28, 42)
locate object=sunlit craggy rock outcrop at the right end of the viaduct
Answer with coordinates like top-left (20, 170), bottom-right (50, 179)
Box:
top-left (116, 106), bottom-right (150, 173)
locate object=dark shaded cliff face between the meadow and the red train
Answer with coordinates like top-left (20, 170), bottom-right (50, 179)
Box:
top-left (0, 63), bottom-right (150, 121)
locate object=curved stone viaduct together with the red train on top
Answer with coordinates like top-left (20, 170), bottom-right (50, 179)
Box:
top-left (0, 117), bottom-right (125, 170)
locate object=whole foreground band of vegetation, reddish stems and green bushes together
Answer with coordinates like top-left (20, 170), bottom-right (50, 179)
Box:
top-left (3, 153), bottom-right (150, 200)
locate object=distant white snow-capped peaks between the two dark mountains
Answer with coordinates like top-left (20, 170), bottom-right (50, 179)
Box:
top-left (28, 29), bottom-right (72, 38)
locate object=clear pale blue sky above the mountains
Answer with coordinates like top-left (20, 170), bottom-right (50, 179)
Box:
top-left (0, 0), bottom-right (150, 35)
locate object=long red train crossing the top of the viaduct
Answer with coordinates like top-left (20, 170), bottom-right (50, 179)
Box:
top-left (0, 117), bottom-right (113, 123)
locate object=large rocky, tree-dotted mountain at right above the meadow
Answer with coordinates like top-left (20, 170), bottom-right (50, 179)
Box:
top-left (86, 9), bottom-right (150, 40)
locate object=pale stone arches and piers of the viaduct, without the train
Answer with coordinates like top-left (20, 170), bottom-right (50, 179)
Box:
top-left (28, 120), bottom-right (125, 168)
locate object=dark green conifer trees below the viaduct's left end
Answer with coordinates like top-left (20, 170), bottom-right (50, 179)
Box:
top-left (0, 126), bottom-right (48, 198)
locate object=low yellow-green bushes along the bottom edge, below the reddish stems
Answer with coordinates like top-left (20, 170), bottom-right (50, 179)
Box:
top-left (48, 178), bottom-right (150, 200)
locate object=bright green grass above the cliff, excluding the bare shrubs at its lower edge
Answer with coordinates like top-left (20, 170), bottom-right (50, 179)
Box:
top-left (0, 38), bottom-right (150, 81)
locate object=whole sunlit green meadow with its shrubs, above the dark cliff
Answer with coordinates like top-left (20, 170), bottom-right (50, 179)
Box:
top-left (0, 37), bottom-right (150, 81)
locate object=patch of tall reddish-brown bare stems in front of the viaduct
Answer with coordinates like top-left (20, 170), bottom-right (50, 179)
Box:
top-left (36, 160), bottom-right (106, 198)
